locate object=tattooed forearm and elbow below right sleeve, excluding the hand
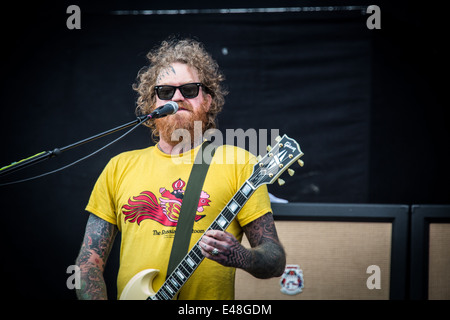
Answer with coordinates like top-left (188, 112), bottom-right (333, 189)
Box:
top-left (242, 213), bottom-right (286, 279)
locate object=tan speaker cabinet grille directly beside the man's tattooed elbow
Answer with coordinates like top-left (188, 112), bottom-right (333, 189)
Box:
top-left (236, 221), bottom-right (392, 300)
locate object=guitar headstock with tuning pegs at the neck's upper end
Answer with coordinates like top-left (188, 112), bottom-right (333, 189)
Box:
top-left (249, 135), bottom-right (303, 187)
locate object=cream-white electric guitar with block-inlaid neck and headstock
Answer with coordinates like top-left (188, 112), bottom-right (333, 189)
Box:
top-left (120, 135), bottom-right (303, 300)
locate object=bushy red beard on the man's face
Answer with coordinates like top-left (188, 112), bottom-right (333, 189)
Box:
top-left (155, 100), bottom-right (207, 147)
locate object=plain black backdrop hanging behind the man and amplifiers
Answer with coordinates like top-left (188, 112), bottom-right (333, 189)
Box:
top-left (0, 1), bottom-right (450, 299)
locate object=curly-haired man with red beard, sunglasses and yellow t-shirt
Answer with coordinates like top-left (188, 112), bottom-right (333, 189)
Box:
top-left (77, 39), bottom-right (286, 299)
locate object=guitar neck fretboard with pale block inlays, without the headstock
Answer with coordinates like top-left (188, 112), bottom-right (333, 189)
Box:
top-left (149, 179), bottom-right (256, 300)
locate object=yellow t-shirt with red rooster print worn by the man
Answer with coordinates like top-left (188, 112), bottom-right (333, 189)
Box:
top-left (86, 146), bottom-right (271, 300)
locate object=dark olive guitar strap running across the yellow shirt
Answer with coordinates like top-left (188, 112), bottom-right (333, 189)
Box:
top-left (166, 141), bottom-right (216, 278)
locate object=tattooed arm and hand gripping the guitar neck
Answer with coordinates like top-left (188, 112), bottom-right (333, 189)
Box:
top-left (200, 213), bottom-right (286, 279)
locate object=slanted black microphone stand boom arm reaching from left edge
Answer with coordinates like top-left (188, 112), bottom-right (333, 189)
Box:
top-left (0, 115), bottom-right (152, 176)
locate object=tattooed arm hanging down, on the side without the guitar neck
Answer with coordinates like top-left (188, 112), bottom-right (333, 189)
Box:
top-left (76, 214), bottom-right (117, 300)
